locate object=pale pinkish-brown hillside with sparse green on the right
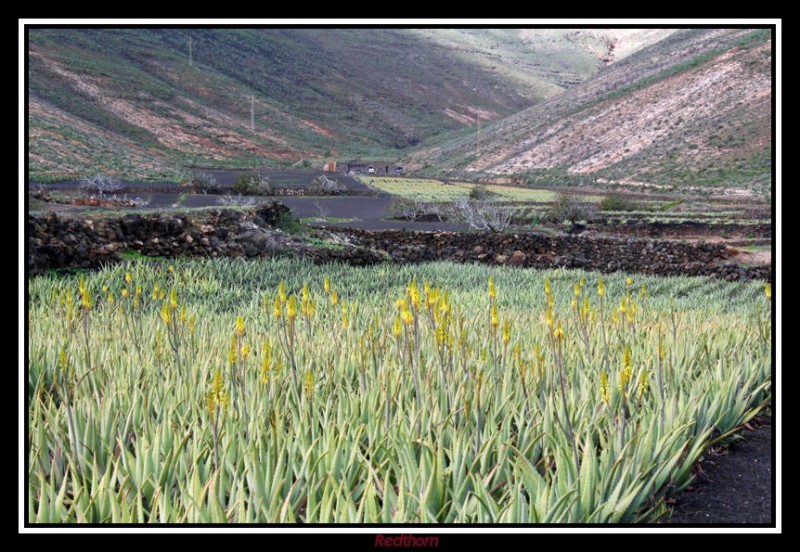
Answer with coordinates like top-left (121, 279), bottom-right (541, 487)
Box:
top-left (417, 29), bottom-right (772, 196)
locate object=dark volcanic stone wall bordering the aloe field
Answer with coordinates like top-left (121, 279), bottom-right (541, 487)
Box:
top-left (28, 202), bottom-right (771, 280)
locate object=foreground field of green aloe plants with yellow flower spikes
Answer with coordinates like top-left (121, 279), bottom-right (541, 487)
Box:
top-left (26, 259), bottom-right (772, 524)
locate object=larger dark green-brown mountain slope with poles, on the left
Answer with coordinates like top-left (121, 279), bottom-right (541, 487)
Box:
top-left (28, 28), bottom-right (669, 178)
